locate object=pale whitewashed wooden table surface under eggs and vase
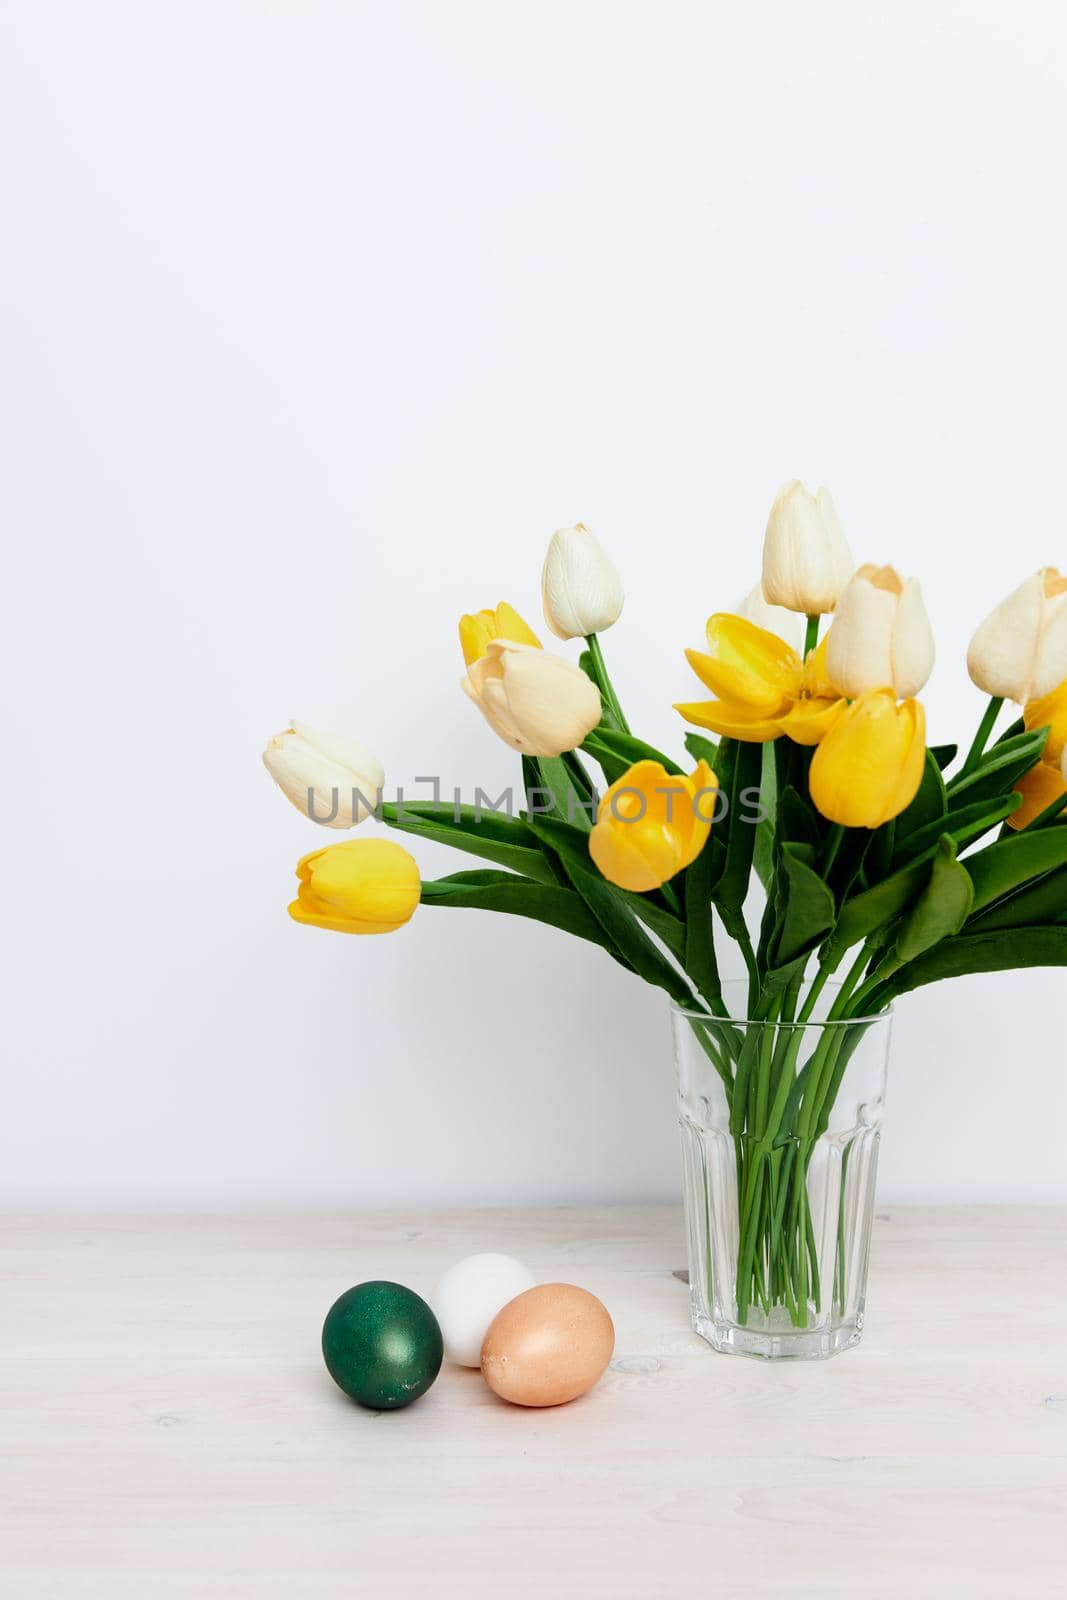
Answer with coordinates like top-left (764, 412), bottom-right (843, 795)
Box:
top-left (0, 1206), bottom-right (1067, 1600)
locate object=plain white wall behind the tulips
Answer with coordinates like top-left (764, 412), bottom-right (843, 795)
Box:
top-left (0, 0), bottom-right (1067, 1208)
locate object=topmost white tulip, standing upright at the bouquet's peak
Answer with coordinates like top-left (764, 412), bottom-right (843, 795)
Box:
top-left (763, 478), bottom-right (854, 616)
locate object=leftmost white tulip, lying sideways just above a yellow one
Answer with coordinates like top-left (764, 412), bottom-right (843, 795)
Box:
top-left (262, 722), bottom-right (386, 827)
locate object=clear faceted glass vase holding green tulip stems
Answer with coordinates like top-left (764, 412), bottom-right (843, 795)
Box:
top-left (672, 984), bottom-right (891, 1360)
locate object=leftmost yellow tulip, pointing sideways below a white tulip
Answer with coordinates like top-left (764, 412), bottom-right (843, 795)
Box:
top-left (290, 838), bottom-right (421, 933)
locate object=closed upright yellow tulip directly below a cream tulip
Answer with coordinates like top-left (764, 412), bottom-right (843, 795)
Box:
top-left (808, 688), bottom-right (926, 827)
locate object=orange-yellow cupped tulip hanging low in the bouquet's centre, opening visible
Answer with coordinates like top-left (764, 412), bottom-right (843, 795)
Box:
top-left (589, 762), bottom-right (718, 894)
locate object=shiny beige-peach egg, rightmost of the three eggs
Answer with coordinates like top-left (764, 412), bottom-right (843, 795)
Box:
top-left (482, 1283), bottom-right (614, 1405)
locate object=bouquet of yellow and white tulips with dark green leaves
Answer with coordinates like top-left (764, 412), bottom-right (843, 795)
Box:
top-left (264, 483), bottom-right (1067, 1301)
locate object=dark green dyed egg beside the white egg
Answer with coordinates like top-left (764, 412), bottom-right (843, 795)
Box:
top-left (322, 1280), bottom-right (445, 1411)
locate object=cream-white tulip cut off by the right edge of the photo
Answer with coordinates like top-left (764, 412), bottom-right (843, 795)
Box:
top-left (966, 566), bottom-right (1067, 706)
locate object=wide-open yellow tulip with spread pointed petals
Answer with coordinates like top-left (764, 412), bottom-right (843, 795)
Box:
top-left (675, 611), bottom-right (845, 744)
